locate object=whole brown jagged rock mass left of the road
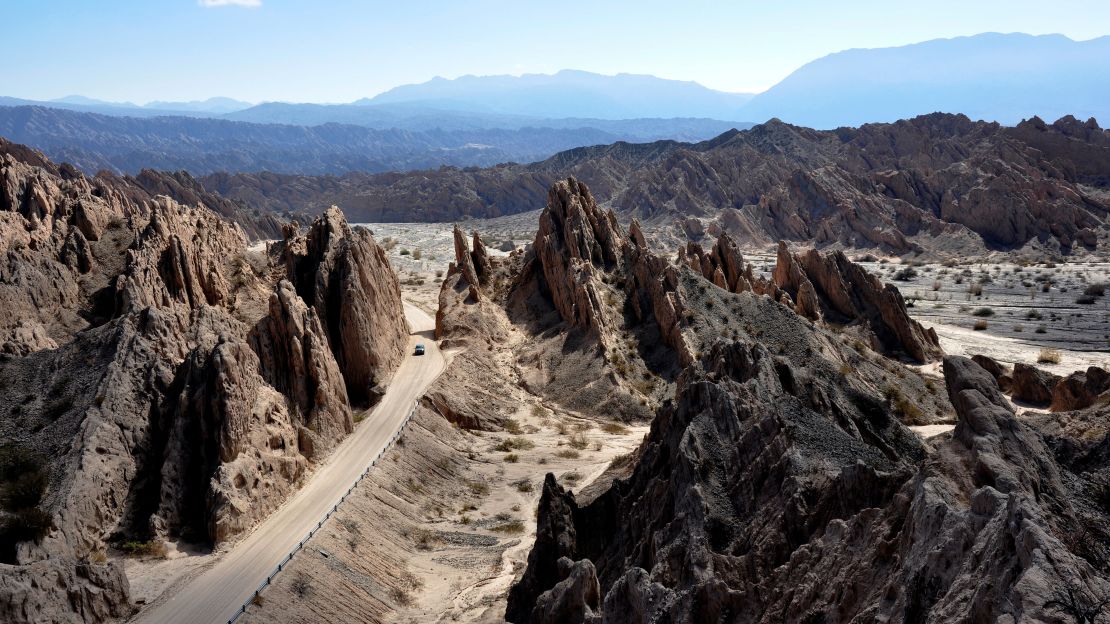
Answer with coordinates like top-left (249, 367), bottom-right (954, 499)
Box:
top-left (0, 139), bottom-right (406, 622)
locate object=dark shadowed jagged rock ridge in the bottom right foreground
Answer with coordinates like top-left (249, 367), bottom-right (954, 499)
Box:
top-left (506, 350), bottom-right (1110, 622)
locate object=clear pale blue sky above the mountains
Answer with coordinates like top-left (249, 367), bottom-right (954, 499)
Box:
top-left (0, 0), bottom-right (1110, 102)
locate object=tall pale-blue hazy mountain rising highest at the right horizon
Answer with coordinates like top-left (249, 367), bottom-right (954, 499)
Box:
top-left (737, 33), bottom-right (1110, 129)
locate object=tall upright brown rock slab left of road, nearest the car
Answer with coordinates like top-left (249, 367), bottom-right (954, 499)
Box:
top-left (283, 207), bottom-right (408, 405)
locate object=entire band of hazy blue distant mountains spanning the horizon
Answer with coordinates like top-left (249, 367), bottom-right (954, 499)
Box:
top-left (0, 33), bottom-right (1110, 175)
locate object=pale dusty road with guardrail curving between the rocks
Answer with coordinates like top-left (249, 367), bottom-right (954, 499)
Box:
top-left (138, 303), bottom-right (444, 624)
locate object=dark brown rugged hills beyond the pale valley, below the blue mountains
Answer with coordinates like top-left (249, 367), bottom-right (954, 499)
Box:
top-left (195, 113), bottom-right (1110, 254)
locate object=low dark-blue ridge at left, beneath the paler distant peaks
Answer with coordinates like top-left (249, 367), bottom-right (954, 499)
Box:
top-left (0, 107), bottom-right (747, 175)
